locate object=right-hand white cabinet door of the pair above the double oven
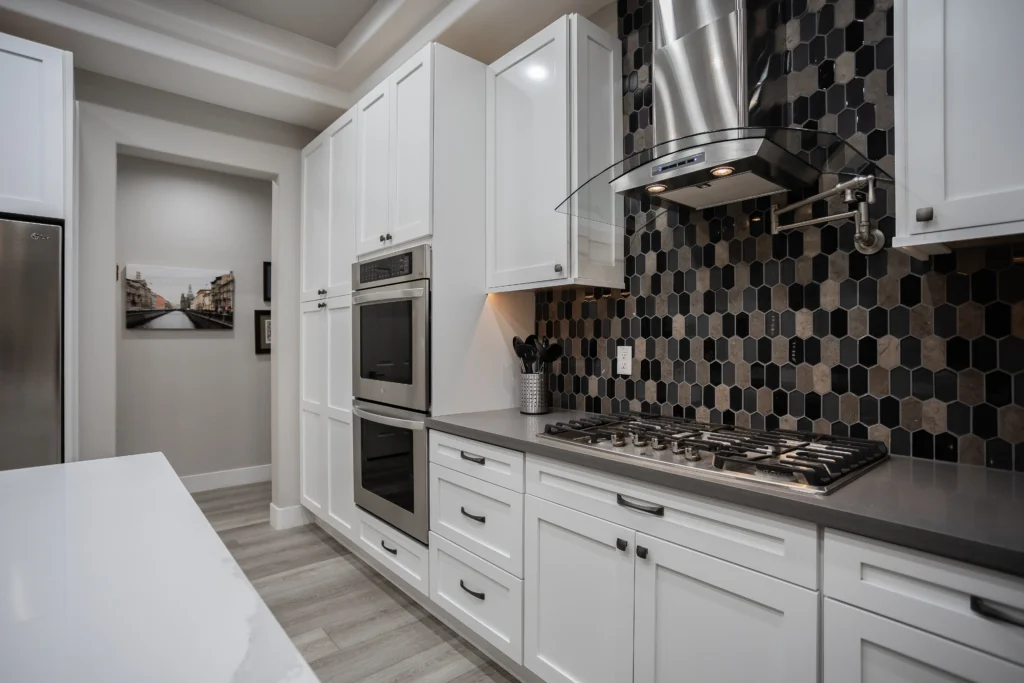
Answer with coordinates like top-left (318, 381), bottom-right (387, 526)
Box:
top-left (387, 45), bottom-right (432, 247)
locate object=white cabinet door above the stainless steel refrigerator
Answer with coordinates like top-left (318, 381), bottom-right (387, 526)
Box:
top-left (0, 34), bottom-right (66, 218)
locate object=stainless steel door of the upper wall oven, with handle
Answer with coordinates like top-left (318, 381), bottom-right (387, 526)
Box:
top-left (352, 280), bottom-right (430, 413)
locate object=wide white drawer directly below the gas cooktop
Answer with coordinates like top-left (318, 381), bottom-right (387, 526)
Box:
top-left (526, 455), bottom-right (818, 590)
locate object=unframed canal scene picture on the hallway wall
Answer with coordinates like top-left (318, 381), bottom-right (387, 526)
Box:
top-left (125, 265), bottom-right (234, 330)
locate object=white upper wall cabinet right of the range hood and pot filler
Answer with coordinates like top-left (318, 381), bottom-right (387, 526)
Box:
top-left (892, 0), bottom-right (1024, 254)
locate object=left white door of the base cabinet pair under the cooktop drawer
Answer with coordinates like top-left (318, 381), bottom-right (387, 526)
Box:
top-left (523, 496), bottom-right (634, 683)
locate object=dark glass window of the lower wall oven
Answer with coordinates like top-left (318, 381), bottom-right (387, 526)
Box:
top-left (359, 420), bottom-right (416, 512)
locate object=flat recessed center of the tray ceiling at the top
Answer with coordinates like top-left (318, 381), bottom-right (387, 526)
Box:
top-left (200, 0), bottom-right (375, 47)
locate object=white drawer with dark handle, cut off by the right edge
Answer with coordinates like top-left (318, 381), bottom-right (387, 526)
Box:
top-left (824, 529), bottom-right (1024, 665)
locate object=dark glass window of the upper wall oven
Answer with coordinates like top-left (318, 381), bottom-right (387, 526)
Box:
top-left (357, 301), bottom-right (413, 384)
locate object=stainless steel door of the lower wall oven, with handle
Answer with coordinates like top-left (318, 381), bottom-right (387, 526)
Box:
top-left (352, 401), bottom-right (430, 544)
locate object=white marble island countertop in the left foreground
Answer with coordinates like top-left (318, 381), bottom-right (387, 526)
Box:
top-left (0, 454), bottom-right (317, 683)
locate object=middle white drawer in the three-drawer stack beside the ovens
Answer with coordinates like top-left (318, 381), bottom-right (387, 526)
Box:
top-left (430, 463), bottom-right (522, 578)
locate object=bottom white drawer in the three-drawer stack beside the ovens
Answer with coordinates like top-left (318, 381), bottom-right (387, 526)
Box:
top-left (430, 532), bottom-right (522, 664)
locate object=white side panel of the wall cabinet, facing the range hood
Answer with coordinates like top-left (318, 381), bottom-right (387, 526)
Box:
top-left (569, 15), bottom-right (625, 283)
